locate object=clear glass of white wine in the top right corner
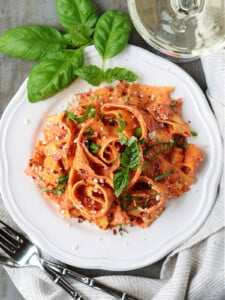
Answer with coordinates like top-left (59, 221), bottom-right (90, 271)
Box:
top-left (127, 0), bottom-right (225, 60)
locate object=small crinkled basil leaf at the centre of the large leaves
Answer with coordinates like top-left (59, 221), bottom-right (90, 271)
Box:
top-left (69, 24), bottom-right (93, 47)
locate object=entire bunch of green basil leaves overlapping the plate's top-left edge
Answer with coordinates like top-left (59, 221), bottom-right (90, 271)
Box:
top-left (0, 0), bottom-right (138, 102)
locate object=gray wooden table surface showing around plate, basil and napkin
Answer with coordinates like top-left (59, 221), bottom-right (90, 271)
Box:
top-left (0, 0), bottom-right (206, 300)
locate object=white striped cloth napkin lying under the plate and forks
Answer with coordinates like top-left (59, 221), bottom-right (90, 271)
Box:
top-left (0, 49), bottom-right (225, 300)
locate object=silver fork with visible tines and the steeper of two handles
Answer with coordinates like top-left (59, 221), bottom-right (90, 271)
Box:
top-left (0, 220), bottom-right (85, 300)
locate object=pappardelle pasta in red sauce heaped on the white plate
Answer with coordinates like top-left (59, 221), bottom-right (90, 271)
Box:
top-left (26, 82), bottom-right (203, 230)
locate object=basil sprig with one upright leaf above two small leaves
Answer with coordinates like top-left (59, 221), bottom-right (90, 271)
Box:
top-left (77, 10), bottom-right (138, 86)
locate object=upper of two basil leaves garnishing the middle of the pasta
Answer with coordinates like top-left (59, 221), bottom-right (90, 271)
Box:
top-left (120, 141), bottom-right (141, 170)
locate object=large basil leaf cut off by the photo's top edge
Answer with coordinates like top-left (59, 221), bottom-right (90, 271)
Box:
top-left (55, 0), bottom-right (98, 31)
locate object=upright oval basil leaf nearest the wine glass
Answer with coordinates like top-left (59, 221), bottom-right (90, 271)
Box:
top-left (94, 10), bottom-right (132, 61)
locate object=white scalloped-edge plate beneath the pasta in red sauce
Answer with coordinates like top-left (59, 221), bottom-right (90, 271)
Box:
top-left (0, 46), bottom-right (222, 271)
